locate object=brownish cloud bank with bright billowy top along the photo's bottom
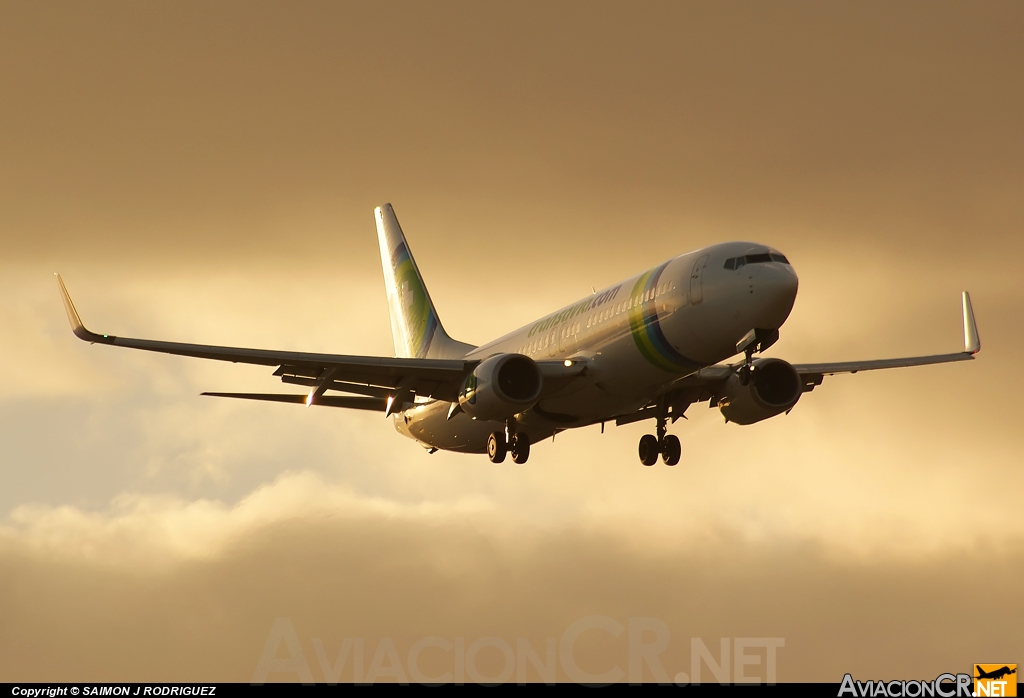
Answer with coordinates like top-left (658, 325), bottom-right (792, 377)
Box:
top-left (0, 475), bottom-right (1024, 682)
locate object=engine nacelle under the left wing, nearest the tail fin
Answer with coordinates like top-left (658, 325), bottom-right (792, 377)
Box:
top-left (459, 354), bottom-right (544, 420)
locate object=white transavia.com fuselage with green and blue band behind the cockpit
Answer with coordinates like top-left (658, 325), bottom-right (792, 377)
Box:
top-left (394, 243), bottom-right (798, 452)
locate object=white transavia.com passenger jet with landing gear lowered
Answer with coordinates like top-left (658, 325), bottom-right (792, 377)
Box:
top-left (56, 198), bottom-right (981, 466)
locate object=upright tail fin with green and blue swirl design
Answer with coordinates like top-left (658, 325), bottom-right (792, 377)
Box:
top-left (374, 204), bottom-right (475, 358)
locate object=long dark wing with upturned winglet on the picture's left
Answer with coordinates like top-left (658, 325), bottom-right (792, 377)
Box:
top-left (56, 274), bottom-right (477, 399)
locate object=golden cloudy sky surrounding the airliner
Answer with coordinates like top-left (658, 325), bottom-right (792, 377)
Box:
top-left (0, 2), bottom-right (1024, 682)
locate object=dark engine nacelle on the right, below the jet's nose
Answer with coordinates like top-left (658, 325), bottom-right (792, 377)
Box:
top-left (718, 358), bottom-right (804, 424)
